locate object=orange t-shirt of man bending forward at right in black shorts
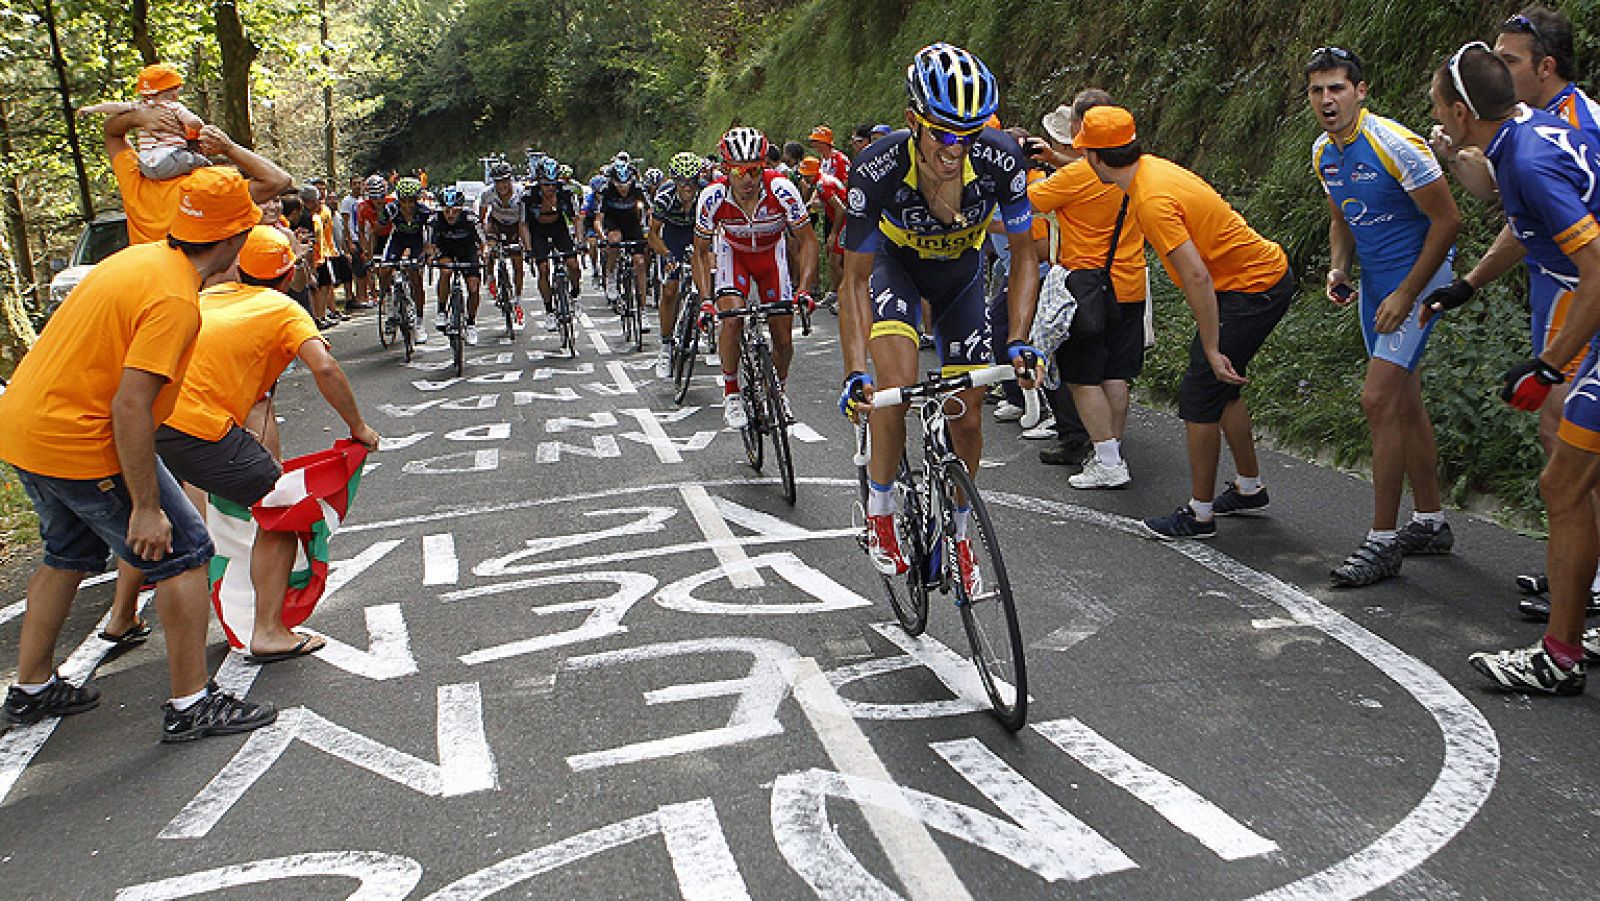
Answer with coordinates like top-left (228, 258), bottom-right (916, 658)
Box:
top-left (1125, 154), bottom-right (1290, 294)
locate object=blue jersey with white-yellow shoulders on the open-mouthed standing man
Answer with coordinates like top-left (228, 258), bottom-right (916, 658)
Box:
top-left (1310, 109), bottom-right (1443, 280)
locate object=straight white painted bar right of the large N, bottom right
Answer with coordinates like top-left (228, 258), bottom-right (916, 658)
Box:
top-left (1034, 719), bottom-right (1278, 861)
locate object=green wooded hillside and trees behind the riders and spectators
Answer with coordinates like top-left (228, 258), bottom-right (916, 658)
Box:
top-left (0, 0), bottom-right (1600, 525)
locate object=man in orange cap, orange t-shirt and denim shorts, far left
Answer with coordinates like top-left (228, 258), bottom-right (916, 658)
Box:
top-left (0, 166), bottom-right (277, 741)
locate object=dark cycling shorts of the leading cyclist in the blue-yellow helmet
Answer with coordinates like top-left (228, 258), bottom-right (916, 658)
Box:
top-left (869, 245), bottom-right (994, 374)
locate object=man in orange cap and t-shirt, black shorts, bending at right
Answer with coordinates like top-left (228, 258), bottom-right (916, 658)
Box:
top-left (1072, 106), bottom-right (1296, 539)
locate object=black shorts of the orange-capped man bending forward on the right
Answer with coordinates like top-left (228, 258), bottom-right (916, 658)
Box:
top-left (1178, 270), bottom-right (1299, 424)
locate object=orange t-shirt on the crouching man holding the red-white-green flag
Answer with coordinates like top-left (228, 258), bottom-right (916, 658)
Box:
top-left (166, 282), bottom-right (322, 442)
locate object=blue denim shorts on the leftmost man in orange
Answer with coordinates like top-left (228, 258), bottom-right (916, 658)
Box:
top-left (16, 459), bottom-right (213, 583)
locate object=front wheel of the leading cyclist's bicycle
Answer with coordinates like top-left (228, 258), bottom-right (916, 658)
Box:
top-left (944, 461), bottom-right (1027, 731)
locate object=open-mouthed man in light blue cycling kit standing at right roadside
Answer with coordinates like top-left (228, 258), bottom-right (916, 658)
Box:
top-left (1306, 46), bottom-right (1461, 587)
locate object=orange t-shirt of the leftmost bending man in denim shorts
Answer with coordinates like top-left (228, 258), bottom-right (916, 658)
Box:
top-left (0, 243), bottom-right (200, 479)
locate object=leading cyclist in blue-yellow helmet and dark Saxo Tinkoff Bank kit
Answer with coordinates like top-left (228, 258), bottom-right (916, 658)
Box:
top-left (838, 43), bottom-right (1038, 586)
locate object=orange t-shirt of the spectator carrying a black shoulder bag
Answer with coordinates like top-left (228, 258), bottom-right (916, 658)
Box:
top-left (1027, 160), bottom-right (1144, 304)
